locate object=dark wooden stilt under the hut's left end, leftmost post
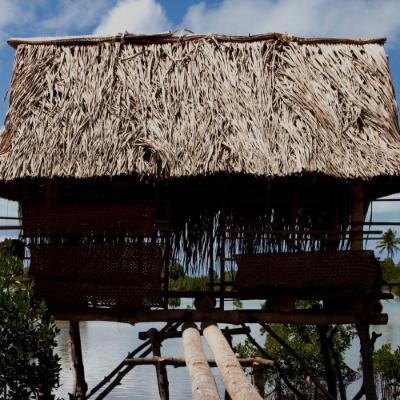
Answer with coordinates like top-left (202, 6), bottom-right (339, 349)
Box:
top-left (69, 321), bottom-right (88, 400)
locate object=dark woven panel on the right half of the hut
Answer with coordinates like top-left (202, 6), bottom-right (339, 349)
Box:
top-left (235, 251), bottom-right (381, 292)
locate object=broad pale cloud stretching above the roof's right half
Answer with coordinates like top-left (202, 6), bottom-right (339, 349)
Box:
top-left (181, 0), bottom-right (400, 38)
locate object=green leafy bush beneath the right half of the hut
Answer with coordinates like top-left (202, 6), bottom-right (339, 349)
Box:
top-left (235, 302), bottom-right (359, 400)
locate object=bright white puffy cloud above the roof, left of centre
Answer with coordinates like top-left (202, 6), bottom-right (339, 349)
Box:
top-left (95, 0), bottom-right (171, 34)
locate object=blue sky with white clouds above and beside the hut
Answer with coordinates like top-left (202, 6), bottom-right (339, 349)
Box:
top-left (0, 0), bottom-right (400, 256)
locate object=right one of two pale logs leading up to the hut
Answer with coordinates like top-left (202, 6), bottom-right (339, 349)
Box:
top-left (203, 324), bottom-right (262, 400)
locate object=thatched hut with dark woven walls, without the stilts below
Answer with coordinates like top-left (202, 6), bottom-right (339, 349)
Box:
top-left (0, 33), bottom-right (400, 400)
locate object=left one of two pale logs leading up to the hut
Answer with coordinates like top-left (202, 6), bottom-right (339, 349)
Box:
top-left (182, 323), bottom-right (219, 400)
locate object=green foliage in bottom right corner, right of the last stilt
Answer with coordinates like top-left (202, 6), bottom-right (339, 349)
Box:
top-left (374, 344), bottom-right (400, 400)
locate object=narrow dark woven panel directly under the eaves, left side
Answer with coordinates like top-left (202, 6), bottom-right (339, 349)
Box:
top-left (22, 203), bottom-right (155, 237)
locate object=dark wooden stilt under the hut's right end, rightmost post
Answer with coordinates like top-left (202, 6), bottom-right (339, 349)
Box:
top-left (356, 323), bottom-right (378, 400)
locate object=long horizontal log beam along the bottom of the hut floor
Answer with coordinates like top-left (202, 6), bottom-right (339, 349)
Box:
top-left (52, 309), bottom-right (388, 325)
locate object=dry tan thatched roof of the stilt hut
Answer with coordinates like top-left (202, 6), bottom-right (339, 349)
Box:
top-left (0, 34), bottom-right (400, 180)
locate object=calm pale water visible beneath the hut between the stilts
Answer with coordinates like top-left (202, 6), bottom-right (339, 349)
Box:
top-left (58, 300), bottom-right (400, 400)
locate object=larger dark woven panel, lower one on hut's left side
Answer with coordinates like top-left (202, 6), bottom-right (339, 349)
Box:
top-left (30, 243), bottom-right (163, 308)
